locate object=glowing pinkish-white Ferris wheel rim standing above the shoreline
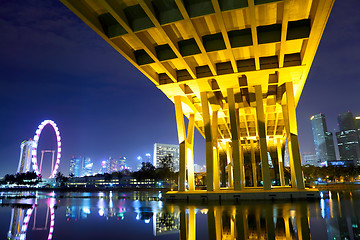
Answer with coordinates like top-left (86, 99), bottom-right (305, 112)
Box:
top-left (32, 120), bottom-right (61, 178)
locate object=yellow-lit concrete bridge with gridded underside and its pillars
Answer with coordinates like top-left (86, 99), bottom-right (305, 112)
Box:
top-left (61, 0), bottom-right (334, 195)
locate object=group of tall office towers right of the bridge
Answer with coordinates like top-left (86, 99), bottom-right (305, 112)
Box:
top-left (310, 112), bottom-right (360, 166)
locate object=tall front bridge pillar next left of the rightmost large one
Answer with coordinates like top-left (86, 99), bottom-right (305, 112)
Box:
top-left (255, 85), bottom-right (271, 190)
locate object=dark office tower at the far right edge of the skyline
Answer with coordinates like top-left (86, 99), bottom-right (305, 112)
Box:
top-left (336, 112), bottom-right (360, 166)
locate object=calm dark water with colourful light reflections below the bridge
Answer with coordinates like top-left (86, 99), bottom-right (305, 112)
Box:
top-left (0, 191), bottom-right (360, 240)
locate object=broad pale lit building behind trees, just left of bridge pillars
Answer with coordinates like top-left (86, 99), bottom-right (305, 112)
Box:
top-left (153, 143), bottom-right (179, 172)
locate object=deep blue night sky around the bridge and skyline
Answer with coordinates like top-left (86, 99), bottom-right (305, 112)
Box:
top-left (0, 0), bottom-right (360, 176)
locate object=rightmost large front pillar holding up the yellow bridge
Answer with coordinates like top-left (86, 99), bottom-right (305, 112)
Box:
top-left (284, 82), bottom-right (305, 189)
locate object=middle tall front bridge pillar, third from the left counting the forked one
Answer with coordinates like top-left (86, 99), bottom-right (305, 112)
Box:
top-left (227, 88), bottom-right (242, 191)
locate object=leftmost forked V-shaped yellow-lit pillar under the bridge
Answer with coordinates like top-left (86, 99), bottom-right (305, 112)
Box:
top-left (174, 96), bottom-right (195, 192)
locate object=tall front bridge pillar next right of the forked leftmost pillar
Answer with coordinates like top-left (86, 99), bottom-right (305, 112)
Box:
top-left (200, 92), bottom-right (214, 191)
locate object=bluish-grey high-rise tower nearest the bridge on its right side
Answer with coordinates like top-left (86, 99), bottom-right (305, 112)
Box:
top-left (310, 114), bottom-right (336, 166)
